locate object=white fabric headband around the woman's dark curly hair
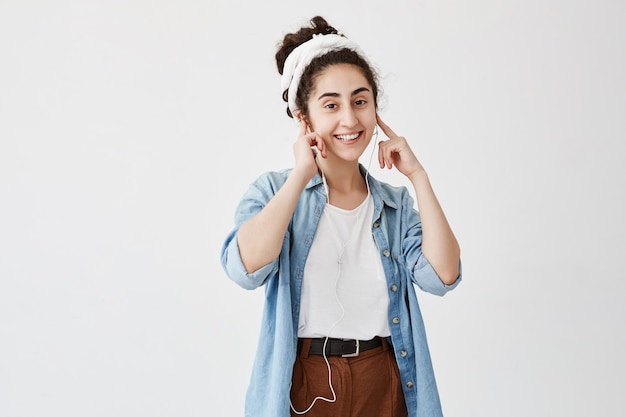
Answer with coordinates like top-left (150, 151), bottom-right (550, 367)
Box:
top-left (280, 33), bottom-right (367, 116)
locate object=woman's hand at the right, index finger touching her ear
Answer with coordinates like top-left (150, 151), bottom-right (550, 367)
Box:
top-left (376, 115), bottom-right (424, 177)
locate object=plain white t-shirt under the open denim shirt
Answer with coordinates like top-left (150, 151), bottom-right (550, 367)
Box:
top-left (298, 193), bottom-right (391, 340)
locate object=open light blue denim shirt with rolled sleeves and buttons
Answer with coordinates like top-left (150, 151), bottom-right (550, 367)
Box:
top-left (221, 166), bottom-right (461, 417)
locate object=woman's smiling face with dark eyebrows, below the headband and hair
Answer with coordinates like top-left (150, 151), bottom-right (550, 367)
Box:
top-left (306, 64), bottom-right (376, 162)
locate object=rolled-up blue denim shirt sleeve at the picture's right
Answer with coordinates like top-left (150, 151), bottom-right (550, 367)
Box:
top-left (402, 188), bottom-right (461, 296)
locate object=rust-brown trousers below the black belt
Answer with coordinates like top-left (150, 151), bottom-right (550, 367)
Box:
top-left (291, 339), bottom-right (407, 417)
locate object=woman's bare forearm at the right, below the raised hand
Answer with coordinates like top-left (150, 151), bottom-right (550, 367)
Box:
top-left (409, 170), bottom-right (460, 285)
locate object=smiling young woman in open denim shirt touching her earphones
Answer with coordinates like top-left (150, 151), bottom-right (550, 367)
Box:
top-left (221, 16), bottom-right (461, 417)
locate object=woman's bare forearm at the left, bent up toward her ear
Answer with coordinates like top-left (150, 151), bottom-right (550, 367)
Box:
top-left (237, 171), bottom-right (308, 273)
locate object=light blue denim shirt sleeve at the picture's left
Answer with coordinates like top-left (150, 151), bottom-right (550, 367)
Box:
top-left (221, 174), bottom-right (278, 290)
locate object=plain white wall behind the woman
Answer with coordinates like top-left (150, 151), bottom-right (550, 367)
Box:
top-left (0, 0), bottom-right (626, 417)
